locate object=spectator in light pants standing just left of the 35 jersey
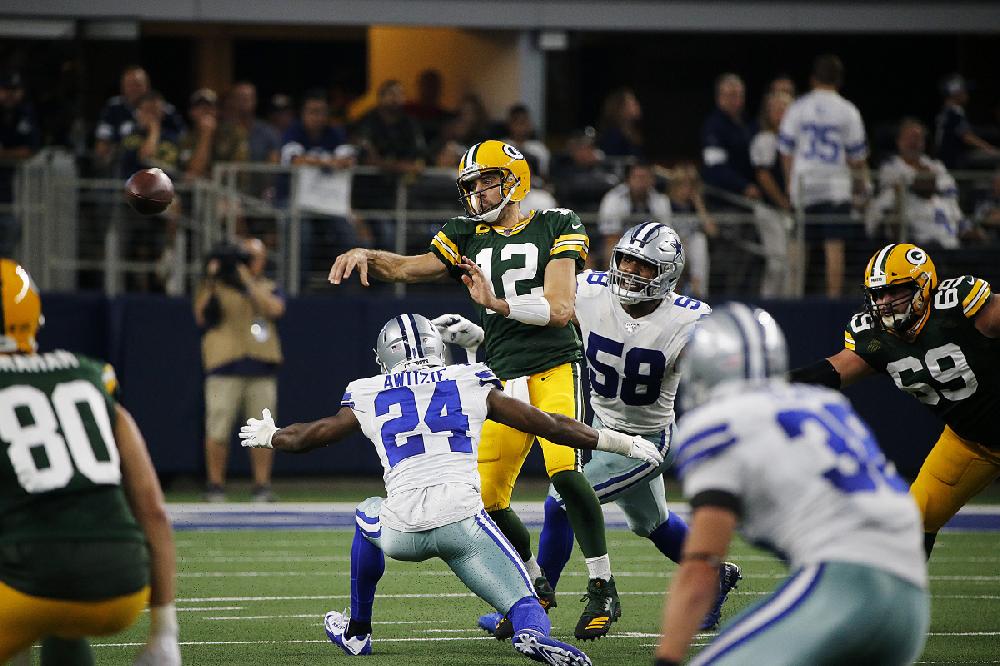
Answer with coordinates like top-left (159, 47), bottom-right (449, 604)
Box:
top-left (750, 92), bottom-right (793, 298)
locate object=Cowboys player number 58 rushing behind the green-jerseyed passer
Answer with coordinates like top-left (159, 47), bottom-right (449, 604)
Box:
top-left (434, 222), bottom-right (740, 638)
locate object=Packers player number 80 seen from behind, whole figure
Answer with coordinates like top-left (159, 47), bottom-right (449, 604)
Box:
top-left (0, 259), bottom-right (181, 666)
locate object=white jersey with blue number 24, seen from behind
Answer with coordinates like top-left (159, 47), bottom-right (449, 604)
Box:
top-left (341, 363), bottom-right (501, 532)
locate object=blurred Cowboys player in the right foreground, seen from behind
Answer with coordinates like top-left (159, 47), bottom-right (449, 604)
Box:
top-left (656, 303), bottom-right (929, 666)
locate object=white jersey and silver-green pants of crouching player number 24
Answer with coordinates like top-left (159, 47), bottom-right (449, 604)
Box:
top-left (341, 364), bottom-right (534, 613)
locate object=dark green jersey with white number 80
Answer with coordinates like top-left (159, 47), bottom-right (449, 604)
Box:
top-left (0, 351), bottom-right (144, 545)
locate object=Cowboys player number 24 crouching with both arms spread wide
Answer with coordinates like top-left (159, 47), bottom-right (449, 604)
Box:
top-left (233, 314), bottom-right (662, 666)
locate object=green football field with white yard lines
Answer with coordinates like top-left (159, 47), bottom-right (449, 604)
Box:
top-left (93, 529), bottom-right (1000, 666)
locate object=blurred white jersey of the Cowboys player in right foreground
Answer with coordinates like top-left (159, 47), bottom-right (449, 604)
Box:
top-left (674, 381), bottom-right (927, 587)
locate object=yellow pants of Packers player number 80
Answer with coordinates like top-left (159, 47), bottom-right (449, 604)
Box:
top-left (0, 582), bottom-right (149, 664)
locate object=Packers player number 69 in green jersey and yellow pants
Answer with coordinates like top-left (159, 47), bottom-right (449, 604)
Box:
top-left (790, 243), bottom-right (1000, 557)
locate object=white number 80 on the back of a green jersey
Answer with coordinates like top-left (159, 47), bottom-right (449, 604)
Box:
top-left (0, 380), bottom-right (121, 493)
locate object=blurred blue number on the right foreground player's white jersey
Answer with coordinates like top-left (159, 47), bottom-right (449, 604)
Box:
top-left (777, 404), bottom-right (906, 494)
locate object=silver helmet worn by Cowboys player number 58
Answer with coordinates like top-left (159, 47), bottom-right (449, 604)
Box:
top-left (608, 222), bottom-right (684, 305)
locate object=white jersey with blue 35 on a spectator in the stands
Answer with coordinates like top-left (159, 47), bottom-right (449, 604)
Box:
top-left (778, 90), bottom-right (868, 206)
